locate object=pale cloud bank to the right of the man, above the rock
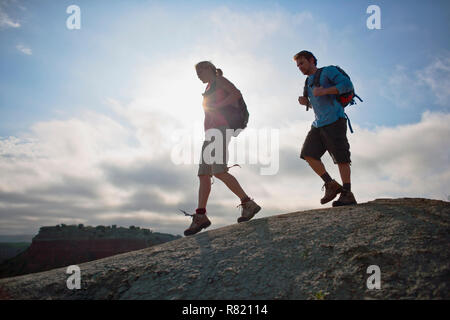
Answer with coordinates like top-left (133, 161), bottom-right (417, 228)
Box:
top-left (351, 112), bottom-right (450, 200)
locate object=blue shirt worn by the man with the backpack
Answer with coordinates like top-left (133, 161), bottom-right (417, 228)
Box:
top-left (307, 66), bottom-right (353, 128)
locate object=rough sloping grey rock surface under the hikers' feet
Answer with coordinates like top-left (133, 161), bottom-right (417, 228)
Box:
top-left (0, 198), bottom-right (450, 299)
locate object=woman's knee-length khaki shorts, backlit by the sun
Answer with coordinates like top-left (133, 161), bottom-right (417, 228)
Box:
top-left (197, 127), bottom-right (231, 176)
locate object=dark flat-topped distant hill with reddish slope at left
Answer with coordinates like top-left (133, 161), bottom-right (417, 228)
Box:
top-left (0, 224), bottom-right (180, 278)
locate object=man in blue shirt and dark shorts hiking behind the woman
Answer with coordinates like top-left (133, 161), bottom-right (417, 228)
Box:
top-left (294, 50), bottom-right (356, 207)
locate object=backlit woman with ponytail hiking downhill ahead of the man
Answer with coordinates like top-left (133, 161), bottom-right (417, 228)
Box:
top-left (184, 61), bottom-right (261, 236)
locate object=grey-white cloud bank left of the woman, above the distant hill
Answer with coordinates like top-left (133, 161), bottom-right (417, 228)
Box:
top-left (0, 107), bottom-right (232, 234)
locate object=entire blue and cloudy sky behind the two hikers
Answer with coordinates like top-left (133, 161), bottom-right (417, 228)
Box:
top-left (0, 0), bottom-right (450, 235)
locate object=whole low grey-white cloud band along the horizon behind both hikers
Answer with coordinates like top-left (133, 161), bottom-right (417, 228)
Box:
top-left (0, 112), bottom-right (450, 238)
